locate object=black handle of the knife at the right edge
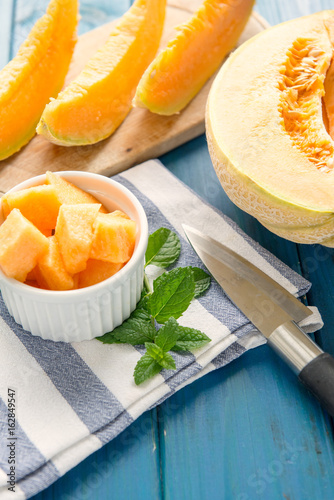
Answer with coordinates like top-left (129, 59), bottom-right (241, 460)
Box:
top-left (298, 352), bottom-right (334, 417)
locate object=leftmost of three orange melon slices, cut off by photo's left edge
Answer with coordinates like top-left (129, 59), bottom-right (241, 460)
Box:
top-left (0, 0), bottom-right (78, 160)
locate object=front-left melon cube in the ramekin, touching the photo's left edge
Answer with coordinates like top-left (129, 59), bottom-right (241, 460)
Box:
top-left (0, 208), bottom-right (49, 281)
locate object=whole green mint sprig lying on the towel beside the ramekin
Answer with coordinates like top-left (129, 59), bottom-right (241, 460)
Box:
top-left (98, 228), bottom-right (211, 385)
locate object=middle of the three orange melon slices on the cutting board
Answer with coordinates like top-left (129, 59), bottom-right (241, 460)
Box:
top-left (37, 0), bottom-right (166, 146)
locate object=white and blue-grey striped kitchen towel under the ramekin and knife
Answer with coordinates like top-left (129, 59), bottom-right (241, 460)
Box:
top-left (0, 161), bottom-right (322, 500)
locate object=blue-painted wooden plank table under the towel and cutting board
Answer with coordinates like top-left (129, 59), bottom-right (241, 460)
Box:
top-left (0, 0), bottom-right (334, 500)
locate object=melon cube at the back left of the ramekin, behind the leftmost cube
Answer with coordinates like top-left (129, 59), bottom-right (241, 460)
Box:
top-left (1, 185), bottom-right (60, 232)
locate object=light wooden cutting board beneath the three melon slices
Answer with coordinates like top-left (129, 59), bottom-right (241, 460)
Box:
top-left (0, 0), bottom-right (268, 193)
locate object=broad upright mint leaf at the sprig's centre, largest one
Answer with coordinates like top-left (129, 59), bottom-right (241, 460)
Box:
top-left (148, 267), bottom-right (195, 323)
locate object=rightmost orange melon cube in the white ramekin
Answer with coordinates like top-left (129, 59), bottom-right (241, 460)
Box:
top-left (90, 213), bottom-right (136, 263)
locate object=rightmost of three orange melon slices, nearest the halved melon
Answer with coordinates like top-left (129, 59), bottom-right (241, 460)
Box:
top-left (133, 0), bottom-right (254, 115)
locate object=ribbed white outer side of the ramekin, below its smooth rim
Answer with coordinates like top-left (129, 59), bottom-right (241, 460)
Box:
top-left (1, 260), bottom-right (144, 342)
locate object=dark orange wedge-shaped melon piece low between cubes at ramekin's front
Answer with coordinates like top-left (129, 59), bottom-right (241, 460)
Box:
top-left (35, 236), bottom-right (73, 290)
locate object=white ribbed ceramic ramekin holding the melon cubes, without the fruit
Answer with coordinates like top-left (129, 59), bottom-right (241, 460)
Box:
top-left (0, 171), bottom-right (148, 342)
